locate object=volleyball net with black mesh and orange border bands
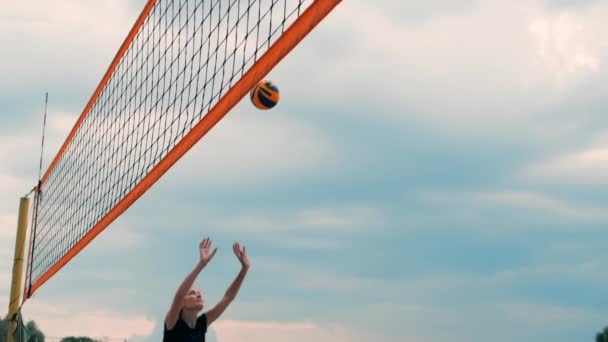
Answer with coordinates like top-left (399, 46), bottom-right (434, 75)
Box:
top-left (17, 0), bottom-right (340, 300)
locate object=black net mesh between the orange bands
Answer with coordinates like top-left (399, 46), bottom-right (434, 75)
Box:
top-left (29, 0), bottom-right (313, 286)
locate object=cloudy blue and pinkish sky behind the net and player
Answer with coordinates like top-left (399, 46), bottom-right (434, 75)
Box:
top-left (0, 0), bottom-right (608, 342)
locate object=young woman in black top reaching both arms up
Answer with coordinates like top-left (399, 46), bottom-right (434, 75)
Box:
top-left (163, 238), bottom-right (250, 342)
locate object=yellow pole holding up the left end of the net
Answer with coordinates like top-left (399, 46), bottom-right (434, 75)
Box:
top-left (8, 197), bottom-right (30, 342)
